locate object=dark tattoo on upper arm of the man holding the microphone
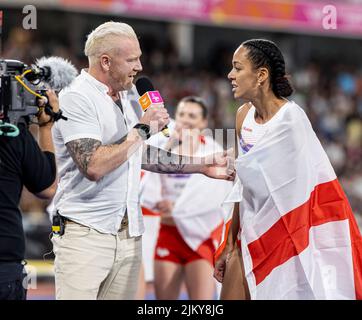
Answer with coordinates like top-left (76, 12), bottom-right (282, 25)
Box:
top-left (66, 138), bottom-right (102, 176)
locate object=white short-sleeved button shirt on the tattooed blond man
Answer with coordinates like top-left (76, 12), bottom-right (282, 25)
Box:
top-left (49, 70), bottom-right (144, 236)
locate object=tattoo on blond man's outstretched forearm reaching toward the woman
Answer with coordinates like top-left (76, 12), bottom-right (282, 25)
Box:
top-left (142, 145), bottom-right (198, 173)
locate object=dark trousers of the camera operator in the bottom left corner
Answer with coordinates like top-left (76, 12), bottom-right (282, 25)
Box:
top-left (0, 262), bottom-right (27, 300)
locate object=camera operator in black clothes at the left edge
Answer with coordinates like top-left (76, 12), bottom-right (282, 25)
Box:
top-left (0, 90), bottom-right (59, 300)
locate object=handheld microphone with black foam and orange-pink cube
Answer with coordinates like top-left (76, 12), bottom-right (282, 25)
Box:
top-left (136, 77), bottom-right (170, 138)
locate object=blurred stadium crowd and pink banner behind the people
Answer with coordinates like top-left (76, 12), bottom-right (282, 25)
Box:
top-left (0, 0), bottom-right (362, 299)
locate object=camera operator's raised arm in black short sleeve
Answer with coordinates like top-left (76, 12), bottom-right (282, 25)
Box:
top-left (23, 91), bottom-right (59, 199)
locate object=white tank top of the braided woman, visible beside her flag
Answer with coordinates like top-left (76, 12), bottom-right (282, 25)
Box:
top-left (240, 106), bottom-right (268, 154)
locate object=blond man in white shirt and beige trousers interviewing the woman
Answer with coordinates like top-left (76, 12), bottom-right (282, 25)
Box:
top-left (49, 22), bottom-right (234, 299)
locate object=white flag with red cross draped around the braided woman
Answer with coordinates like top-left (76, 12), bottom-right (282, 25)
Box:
top-left (235, 102), bottom-right (362, 299)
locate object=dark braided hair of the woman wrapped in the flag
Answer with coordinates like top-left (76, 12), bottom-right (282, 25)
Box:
top-left (242, 39), bottom-right (293, 98)
